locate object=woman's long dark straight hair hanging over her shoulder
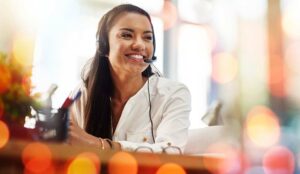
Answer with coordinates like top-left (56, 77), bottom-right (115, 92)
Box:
top-left (82, 4), bottom-right (155, 139)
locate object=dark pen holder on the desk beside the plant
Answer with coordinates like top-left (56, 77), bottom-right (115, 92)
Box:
top-left (35, 108), bottom-right (69, 142)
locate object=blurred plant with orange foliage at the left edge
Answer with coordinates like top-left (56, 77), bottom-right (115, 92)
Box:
top-left (0, 52), bottom-right (38, 138)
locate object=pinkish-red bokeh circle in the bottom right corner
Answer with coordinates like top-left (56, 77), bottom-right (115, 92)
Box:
top-left (263, 146), bottom-right (295, 174)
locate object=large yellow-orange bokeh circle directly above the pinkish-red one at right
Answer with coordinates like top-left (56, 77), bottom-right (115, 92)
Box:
top-left (246, 106), bottom-right (280, 147)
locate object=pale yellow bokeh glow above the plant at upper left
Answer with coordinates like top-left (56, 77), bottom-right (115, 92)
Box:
top-left (13, 34), bottom-right (34, 66)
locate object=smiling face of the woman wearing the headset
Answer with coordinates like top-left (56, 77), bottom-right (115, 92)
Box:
top-left (108, 13), bottom-right (153, 75)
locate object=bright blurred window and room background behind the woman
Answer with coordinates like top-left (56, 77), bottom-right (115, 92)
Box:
top-left (0, 0), bottom-right (300, 173)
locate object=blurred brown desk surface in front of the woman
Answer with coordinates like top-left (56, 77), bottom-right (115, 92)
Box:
top-left (0, 140), bottom-right (223, 174)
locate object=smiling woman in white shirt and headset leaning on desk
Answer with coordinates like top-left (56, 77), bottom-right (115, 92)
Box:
top-left (69, 4), bottom-right (190, 152)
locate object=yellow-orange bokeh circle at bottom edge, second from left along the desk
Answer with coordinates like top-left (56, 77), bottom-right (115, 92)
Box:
top-left (68, 152), bottom-right (101, 174)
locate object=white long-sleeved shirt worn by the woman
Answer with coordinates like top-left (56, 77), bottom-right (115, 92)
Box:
top-left (70, 75), bottom-right (191, 152)
